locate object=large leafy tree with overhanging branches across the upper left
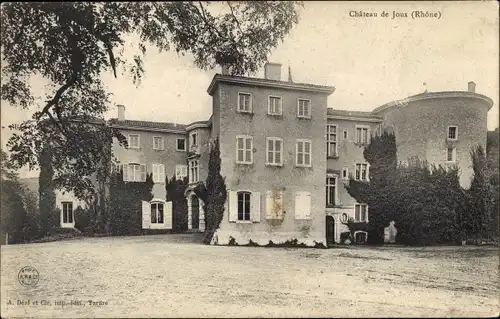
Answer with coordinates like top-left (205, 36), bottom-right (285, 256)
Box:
top-left (0, 1), bottom-right (298, 198)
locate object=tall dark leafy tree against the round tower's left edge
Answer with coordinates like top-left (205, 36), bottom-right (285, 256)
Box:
top-left (345, 132), bottom-right (397, 243)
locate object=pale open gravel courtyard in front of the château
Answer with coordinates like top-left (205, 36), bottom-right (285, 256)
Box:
top-left (1, 235), bottom-right (499, 318)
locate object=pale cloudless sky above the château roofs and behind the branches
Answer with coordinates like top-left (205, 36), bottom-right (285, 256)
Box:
top-left (1, 1), bottom-right (499, 178)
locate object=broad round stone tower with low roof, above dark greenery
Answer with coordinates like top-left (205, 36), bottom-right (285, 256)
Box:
top-left (372, 82), bottom-right (493, 188)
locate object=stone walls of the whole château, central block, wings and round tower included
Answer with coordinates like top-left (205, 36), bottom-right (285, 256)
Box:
top-left (54, 64), bottom-right (493, 246)
